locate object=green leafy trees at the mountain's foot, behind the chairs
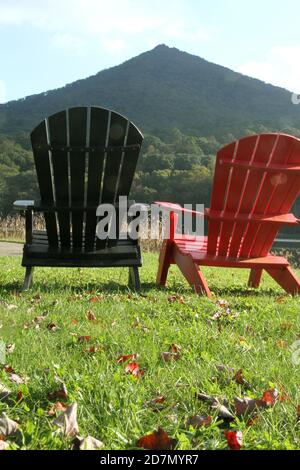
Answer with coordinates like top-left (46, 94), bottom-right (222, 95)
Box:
top-left (0, 126), bottom-right (300, 222)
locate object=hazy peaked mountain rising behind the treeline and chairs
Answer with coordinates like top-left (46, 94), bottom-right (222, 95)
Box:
top-left (0, 45), bottom-right (300, 139)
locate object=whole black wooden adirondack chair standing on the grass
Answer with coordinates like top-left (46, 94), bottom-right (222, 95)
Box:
top-left (14, 107), bottom-right (143, 289)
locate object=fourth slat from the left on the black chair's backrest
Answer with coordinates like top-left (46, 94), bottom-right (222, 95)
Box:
top-left (85, 108), bottom-right (109, 250)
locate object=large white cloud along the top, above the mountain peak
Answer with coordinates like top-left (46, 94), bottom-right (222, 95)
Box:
top-left (0, 0), bottom-right (210, 54)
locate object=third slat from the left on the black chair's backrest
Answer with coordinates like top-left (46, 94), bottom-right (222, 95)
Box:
top-left (69, 108), bottom-right (87, 250)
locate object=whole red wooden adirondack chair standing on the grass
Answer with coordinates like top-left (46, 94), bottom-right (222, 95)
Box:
top-left (156, 133), bottom-right (300, 296)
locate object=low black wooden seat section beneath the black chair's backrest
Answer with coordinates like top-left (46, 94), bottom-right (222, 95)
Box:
top-left (22, 230), bottom-right (141, 267)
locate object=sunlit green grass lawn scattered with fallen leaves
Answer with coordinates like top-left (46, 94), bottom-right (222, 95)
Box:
top-left (0, 254), bottom-right (300, 449)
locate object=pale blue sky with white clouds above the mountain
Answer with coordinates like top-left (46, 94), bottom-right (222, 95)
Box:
top-left (0, 0), bottom-right (300, 103)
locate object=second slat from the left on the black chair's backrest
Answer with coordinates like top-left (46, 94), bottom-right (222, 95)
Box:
top-left (49, 111), bottom-right (70, 248)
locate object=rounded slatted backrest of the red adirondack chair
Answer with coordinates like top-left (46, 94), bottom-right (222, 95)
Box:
top-left (207, 133), bottom-right (300, 258)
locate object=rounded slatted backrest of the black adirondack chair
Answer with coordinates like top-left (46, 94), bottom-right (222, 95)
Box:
top-left (31, 107), bottom-right (143, 250)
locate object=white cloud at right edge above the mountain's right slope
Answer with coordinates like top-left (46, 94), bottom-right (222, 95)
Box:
top-left (237, 46), bottom-right (300, 93)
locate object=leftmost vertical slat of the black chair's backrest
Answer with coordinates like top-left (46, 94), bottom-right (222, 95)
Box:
top-left (31, 121), bottom-right (58, 248)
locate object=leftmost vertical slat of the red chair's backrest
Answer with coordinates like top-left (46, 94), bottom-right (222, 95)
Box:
top-left (207, 142), bottom-right (237, 255)
